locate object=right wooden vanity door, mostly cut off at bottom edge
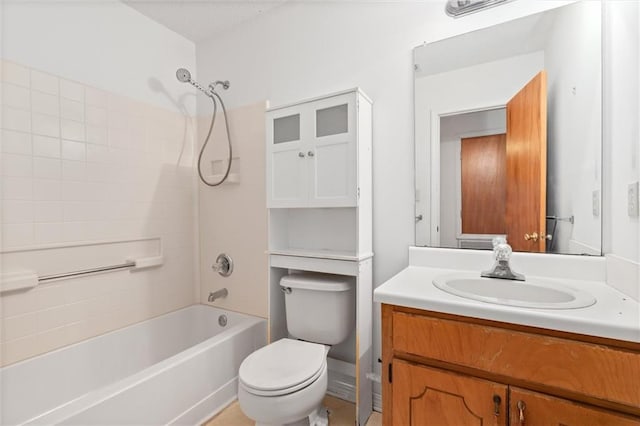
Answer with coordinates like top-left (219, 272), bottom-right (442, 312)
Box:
top-left (509, 387), bottom-right (640, 426)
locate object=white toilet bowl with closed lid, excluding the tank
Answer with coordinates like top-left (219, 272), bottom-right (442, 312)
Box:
top-left (238, 339), bottom-right (328, 425)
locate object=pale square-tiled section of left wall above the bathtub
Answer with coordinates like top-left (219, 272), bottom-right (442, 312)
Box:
top-left (0, 61), bottom-right (196, 365)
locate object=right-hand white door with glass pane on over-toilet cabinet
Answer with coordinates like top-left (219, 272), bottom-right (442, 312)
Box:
top-left (306, 93), bottom-right (358, 207)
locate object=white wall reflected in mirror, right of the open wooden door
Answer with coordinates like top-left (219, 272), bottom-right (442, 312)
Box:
top-left (544, 2), bottom-right (602, 255)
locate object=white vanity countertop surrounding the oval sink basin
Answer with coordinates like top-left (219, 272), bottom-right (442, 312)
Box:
top-left (374, 266), bottom-right (640, 342)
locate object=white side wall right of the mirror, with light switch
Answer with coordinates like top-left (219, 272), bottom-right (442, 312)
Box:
top-left (603, 1), bottom-right (640, 299)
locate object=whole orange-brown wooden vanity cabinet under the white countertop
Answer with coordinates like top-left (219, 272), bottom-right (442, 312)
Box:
top-left (382, 304), bottom-right (640, 426)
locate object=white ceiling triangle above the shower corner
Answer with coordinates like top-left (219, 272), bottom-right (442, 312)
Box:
top-left (122, 0), bottom-right (288, 42)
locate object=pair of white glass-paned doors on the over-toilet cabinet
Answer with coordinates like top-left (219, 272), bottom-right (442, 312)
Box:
top-left (267, 92), bottom-right (358, 208)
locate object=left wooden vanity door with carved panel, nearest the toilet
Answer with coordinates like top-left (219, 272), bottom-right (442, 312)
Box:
top-left (392, 360), bottom-right (507, 426)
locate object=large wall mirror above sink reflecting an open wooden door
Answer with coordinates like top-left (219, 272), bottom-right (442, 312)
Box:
top-left (414, 1), bottom-right (602, 255)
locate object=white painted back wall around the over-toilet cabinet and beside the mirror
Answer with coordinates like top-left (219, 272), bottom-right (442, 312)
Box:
top-left (197, 1), bottom-right (566, 402)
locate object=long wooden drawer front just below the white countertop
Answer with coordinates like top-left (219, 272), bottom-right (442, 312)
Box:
top-left (393, 312), bottom-right (640, 407)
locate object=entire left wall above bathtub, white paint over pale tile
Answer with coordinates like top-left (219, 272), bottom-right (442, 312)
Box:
top-left (0, 2), bottom-right (197, 364)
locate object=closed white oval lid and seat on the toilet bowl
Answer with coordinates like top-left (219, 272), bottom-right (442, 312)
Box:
top-left (238, 339), bottom-right (327, 395)
